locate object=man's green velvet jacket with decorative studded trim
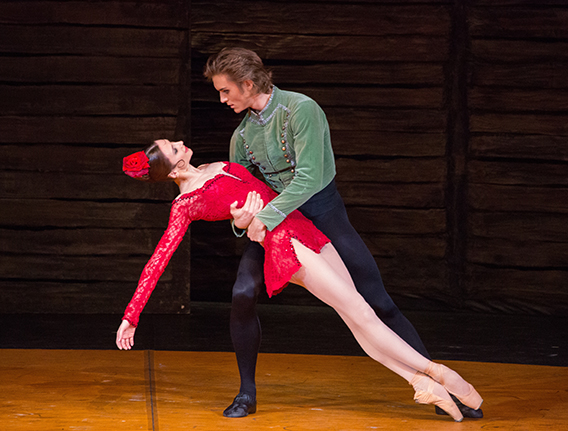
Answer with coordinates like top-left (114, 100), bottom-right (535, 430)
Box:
top-left (230, 86), bottom-right (335, 230)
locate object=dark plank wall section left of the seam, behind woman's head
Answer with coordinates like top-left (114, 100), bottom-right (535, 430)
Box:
top-left (0, 0), bottom-right (189, 313)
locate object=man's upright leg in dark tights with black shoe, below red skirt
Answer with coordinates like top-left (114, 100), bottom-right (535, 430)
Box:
top-left (223, 241), bottom-right (264, 417)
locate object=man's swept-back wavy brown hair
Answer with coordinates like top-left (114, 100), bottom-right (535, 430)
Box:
top-left (203, 48), bottom-right (272, 93)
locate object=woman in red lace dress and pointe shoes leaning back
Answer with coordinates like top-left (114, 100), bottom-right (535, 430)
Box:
top-left (116, 139), bottom-right (483, 422)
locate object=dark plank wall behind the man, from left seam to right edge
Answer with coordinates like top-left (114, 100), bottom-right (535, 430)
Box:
top-left (191, 0), bottom-right (568, 313)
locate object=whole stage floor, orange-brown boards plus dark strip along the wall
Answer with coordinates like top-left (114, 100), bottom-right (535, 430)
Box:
top-left (0, 303), bottom-right (568, 431)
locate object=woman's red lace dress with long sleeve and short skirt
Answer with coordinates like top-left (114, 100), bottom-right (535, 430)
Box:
top-left (123, 163), bottom-right (330, 326)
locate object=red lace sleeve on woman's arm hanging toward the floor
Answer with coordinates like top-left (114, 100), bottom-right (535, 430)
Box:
top-left (122, 202), bottom-right (192, 326)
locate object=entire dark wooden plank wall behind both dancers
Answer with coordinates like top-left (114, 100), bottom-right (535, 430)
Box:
top-left (0, 0), bottom-right (568, 313)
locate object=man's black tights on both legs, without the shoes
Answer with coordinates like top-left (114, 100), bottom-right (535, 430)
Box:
top-left (231, 182), bottom-right (430, 396)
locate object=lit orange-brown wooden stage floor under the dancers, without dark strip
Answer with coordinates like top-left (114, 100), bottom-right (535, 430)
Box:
top-left (0, 349), bottom-right (568, 431)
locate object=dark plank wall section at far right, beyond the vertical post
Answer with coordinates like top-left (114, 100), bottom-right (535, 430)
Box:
top-left (465, 0), bottom-right (568, 313)
